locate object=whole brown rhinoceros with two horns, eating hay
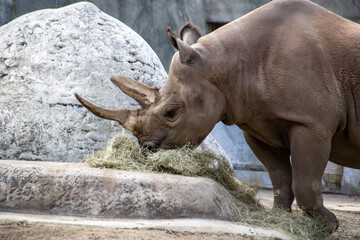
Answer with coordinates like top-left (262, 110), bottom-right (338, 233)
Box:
top-left (76, 0), bottom-right (360, 227)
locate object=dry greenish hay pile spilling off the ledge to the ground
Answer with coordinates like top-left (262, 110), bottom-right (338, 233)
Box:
top-left (85, 133), bottom-right (331, 239)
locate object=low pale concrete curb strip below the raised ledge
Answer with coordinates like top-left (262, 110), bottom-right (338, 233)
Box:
top-left (0, 212), bottom-right (291, 239)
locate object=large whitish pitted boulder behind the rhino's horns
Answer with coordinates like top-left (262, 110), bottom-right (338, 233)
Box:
top-left (0, 2), bottom-right (226, 161)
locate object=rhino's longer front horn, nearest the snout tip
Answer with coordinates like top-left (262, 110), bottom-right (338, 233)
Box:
top-left (75, 93), bottom-right (138, 131)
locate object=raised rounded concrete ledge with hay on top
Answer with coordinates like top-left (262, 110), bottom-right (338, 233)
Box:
top-left (0, 160), bottom-right (235, 220)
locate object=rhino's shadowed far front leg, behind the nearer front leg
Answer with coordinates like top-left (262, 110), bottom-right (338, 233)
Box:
top-left (244, 132), bottom-right (294, 211)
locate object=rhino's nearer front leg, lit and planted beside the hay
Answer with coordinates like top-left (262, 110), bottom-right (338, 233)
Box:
top-left (290, 126), bottom-right (339, 231)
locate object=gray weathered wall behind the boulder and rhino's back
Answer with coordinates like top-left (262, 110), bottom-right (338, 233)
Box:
top-left (0, 0), bottom-right (360, 70)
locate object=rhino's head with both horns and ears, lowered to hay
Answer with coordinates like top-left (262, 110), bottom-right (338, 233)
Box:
top-left (75, 24), bottom-right (226, 150)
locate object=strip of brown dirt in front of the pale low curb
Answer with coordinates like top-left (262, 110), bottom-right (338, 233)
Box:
top-left (0, 222), bottom-right (265, 240)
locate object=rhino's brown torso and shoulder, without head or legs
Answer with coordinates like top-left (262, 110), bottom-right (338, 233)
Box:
top-left (199, 0), bottom-right (360, 168)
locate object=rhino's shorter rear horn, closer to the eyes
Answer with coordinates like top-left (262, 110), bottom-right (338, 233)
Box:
top-left (110, 76), bottom-right (158, 108)
